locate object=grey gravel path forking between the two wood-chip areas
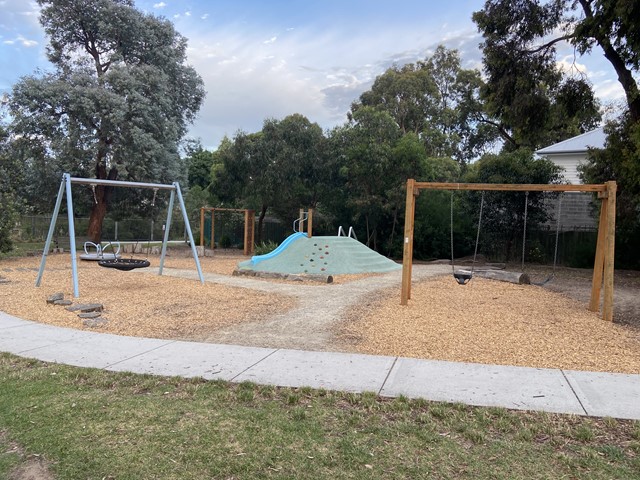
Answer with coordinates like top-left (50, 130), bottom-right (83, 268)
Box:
top-left (156, 265), bottom-right (450, 351)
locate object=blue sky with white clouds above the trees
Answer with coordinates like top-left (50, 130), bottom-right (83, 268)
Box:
top-left (0, 0), bottom-right (623, 149)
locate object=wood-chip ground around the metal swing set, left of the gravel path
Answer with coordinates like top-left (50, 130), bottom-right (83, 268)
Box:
top-left (0, 255), bottom-right (295, 340)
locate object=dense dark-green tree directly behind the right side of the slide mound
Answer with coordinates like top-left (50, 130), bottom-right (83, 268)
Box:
top-left (326, 106), bottom-right (426, 252)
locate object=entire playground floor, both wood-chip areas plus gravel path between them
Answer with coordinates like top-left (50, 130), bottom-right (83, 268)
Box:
top-left (0, 255), bottom-right (640, 373)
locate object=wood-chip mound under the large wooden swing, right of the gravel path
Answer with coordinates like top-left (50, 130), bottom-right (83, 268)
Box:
top-left (342, 277), bottom-right (640, 374)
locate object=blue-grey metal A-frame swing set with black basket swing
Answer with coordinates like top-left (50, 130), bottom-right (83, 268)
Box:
top-left (36, 173), bottom-right (204, 298)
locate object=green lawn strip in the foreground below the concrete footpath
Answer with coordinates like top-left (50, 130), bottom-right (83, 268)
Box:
top-left (0, 354), bottom-right (640, 480)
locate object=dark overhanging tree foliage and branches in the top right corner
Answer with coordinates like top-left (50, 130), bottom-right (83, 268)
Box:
top-left (473, 0), bottom-right (640, 148)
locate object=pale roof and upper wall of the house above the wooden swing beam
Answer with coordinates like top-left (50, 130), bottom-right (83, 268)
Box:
top-left (536, 127), bottom-right (607, 184)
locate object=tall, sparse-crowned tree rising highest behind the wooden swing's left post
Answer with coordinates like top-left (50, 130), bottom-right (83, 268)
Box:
top-left (349, 45), bottom-right (498, 163)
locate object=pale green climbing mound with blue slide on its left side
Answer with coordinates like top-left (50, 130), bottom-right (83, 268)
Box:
top-left (238, 234), bottom-right (402, 275)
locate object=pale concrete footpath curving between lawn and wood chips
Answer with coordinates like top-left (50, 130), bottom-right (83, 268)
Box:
top-left (0, 312), bottom-right (640, 420)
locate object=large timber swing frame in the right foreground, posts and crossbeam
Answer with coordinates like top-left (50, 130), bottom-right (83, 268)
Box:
top-left (400, 178), bottom-right (617, 321)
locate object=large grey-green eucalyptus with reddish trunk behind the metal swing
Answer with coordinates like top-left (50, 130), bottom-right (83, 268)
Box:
top-left (10, 0), bottom-right (205, 241)
